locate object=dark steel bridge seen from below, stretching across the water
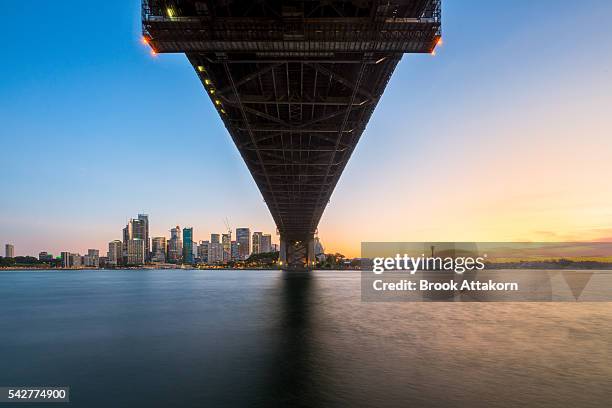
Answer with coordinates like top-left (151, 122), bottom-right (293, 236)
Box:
top-left (142, 0), bottom-right (441, 268)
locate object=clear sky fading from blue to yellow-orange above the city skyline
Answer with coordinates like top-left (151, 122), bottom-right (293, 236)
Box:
top-left (0, 0), bottom-right (612, 256)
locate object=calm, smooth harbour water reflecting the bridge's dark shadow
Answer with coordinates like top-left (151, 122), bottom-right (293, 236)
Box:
top-left (0, 270), bottom-right (612, 407)
